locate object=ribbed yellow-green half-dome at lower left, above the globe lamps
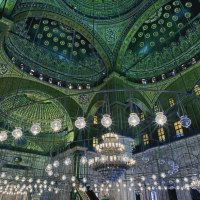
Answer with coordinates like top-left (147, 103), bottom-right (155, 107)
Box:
top-left (0, 91), bottom-right (71, 133)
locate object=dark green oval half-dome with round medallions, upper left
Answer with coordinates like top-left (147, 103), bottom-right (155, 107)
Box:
top-left (6, 17), bottom-right (106, 84)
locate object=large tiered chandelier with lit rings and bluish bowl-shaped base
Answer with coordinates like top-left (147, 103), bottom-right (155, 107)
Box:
top-left (88, 133), bottom-right (135, 182)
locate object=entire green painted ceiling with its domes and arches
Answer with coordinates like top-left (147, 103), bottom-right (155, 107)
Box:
top-left (0, 0), bottom-right (200, 153)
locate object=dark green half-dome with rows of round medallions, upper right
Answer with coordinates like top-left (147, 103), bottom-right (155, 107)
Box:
top-left (118, 0), bottom-right (200, 81)
